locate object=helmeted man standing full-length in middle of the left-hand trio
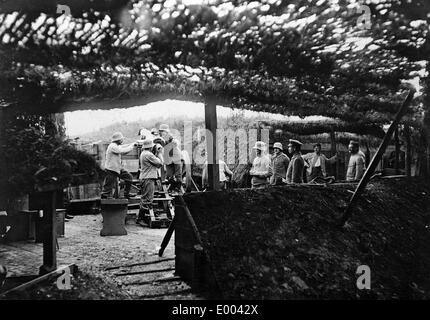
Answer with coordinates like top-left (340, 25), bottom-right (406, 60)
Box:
top-left (138, 139), bottom-right (163, 220)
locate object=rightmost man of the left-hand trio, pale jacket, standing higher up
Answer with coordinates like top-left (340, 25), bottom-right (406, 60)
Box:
top-left (159, 124), bottom-right (182, 191)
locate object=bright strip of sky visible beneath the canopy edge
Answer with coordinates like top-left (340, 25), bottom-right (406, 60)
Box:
top-left (64, 100), bottom-right (322, 136)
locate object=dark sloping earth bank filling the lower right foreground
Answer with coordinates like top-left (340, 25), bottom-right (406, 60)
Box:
top-left (185, 179), bottom-right (430, 299)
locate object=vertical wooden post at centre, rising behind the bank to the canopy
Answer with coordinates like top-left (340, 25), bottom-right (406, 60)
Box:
top-left (205, 96), bottom-right (219, 190)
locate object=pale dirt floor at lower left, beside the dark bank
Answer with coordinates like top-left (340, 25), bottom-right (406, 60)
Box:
top-left (0, 215), bottom-right (200, 300)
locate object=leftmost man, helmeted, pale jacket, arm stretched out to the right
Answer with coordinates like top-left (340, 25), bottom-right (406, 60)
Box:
top-left (101, 132), bottom-right (137, 198)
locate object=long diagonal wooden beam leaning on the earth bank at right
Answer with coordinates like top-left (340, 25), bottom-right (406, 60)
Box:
top-left (340, 89), bottom-right (415, 227)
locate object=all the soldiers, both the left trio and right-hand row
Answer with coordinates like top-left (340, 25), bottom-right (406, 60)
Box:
top-left (102, 124), bottom-right (365, 214)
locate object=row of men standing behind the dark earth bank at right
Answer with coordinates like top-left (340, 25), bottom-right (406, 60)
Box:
top-left (249, 139), bottom-right (366, 188)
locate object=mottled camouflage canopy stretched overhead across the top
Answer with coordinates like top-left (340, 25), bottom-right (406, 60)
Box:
top-left (0, 0), bottom-right (424, 124)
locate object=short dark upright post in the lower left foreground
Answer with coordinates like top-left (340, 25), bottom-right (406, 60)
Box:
top-left (39, 190), bottom-right (57, 275)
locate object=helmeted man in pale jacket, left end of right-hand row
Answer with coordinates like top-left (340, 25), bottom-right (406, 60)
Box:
top-left (249, 141), bottom-right (272, 189)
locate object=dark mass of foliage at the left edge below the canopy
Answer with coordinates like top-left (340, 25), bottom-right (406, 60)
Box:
top-left (2, 115), bottom-right (100, 196)
